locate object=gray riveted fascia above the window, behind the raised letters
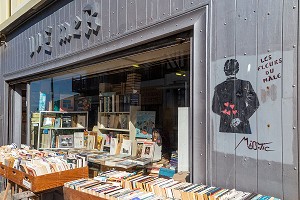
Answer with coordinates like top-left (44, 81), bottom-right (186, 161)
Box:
top-left (1, 0), bottom-right (211, 73)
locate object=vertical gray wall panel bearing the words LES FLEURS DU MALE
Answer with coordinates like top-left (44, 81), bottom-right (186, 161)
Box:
top-left (257, 0), bottom-right (283, 198)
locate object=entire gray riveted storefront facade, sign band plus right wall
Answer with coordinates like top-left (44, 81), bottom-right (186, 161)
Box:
top-left (0, 0), bottom-right (299, 200)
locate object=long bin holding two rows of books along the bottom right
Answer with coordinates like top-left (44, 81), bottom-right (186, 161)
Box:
top-left (64, 171), bottom-right (279, 200)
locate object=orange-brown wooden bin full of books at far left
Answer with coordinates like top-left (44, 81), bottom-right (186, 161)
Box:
top-left (0, 145), bottom-right (88, 193)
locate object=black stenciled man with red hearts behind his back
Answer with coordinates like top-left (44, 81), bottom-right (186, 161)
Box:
top-left (212, 59), bottom-right (259, 134)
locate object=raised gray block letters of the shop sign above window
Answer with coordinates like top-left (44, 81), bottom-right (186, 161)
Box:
top-left (29, 3), bottom-right (101, 57)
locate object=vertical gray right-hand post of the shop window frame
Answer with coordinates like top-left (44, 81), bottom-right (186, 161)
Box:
top-left (190, 6), bottom-right (210, 184)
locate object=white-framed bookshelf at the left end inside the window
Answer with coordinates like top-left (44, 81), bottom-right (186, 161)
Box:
top-left (37, 111), bottom-right (88, 149)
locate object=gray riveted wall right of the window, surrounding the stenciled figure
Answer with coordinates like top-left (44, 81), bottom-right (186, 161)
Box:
top-left (210, 0), bottom-right (299, 199)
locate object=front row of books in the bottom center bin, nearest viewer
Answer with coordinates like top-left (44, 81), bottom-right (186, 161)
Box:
top-left (64, 179), bottom-right (160, 200)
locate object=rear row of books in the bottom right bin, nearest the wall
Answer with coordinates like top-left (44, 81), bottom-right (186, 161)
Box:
top-left (121, 175), bottom-right (277, 200)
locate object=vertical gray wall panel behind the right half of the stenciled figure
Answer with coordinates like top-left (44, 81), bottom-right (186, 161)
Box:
top-left (235, 0), bottom-right (259, 192)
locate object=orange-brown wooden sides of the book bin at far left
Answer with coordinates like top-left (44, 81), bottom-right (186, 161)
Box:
top-left (0, 164), bottom-right (88, 193)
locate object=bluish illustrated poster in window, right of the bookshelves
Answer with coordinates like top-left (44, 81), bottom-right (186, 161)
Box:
top-left (135, 111), bottom-right (155, 138)
